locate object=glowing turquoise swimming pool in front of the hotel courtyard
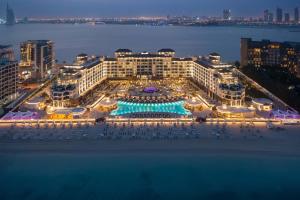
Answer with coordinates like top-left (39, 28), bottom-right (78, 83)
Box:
top-left (111, 101), bottom-right (191, 116)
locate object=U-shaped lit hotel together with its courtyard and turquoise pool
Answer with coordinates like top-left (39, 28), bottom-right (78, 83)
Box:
top-left (49, 49), bottom-right (248, 117)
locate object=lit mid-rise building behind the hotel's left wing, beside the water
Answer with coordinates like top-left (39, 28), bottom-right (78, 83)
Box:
top-left (19, 40), bottom-right (55, 82)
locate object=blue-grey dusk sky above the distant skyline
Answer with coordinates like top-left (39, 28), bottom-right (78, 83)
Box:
top-left (0, 0), bottom-right (300, 17)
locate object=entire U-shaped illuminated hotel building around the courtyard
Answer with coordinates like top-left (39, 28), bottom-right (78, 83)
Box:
top-left (51, 49), bottom-right (245, 107)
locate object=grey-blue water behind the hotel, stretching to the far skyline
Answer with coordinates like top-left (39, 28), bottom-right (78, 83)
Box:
top-left (0, 24), bottom-right (300, 62)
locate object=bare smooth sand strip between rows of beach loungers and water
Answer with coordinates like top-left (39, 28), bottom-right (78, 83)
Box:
top-left (0, 139), bottom-right (300, 158)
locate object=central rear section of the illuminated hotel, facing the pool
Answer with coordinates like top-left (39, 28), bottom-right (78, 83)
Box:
top-left (102, 49), bottom-right (193, 79)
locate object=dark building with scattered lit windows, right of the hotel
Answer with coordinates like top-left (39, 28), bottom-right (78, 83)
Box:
top-left (241, 38), bottom-right (300, 76)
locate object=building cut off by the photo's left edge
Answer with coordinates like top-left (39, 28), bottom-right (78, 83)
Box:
top-left (0, 45), bottom-right (18, 106)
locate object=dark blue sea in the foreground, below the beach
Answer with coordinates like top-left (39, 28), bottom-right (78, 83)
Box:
top-left (0, 153), bottom-right (300, 200)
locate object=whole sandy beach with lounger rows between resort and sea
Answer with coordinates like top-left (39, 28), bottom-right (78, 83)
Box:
top-left (0, 124), bottom-right (300, 157)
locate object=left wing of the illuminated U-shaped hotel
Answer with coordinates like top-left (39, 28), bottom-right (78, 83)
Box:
top-left (51, 54), bottom-right (106, 107)
